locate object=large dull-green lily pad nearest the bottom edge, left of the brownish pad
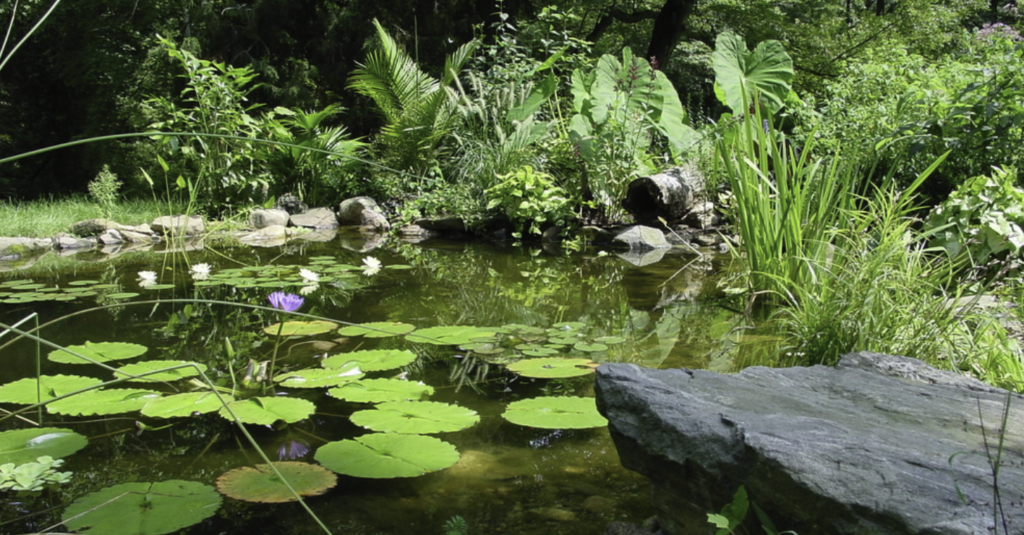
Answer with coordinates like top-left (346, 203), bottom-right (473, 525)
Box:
top-left (62, 480), bottom-right (222, 535)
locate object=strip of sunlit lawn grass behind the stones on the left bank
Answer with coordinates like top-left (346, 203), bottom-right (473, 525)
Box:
top-left (0, 196), bottom-right (167, 238)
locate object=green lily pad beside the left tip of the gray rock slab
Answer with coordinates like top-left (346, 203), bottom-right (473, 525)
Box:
top-left (502, 397), bottom-right (608, 429)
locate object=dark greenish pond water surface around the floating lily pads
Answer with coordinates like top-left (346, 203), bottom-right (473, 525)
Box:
top-left (0, 241), bottom-right (770, 534)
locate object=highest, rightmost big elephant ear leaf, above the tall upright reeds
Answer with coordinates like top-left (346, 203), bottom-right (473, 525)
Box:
top-left (712, 32), bottom-right (793, 115)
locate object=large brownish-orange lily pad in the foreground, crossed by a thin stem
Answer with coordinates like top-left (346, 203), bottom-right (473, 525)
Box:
top-left (217, 461), bottom-right (338, 503)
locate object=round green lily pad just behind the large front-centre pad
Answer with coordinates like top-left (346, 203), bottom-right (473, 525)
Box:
top-left (351, 401), bottom-right (480, 435)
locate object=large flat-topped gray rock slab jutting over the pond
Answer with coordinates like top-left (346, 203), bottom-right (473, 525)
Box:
top-left (596, 353), bottom-right (1024, 535)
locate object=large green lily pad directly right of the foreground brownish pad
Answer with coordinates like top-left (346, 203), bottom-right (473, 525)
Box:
top-left (315, 433), bottom-right (459, 479)
